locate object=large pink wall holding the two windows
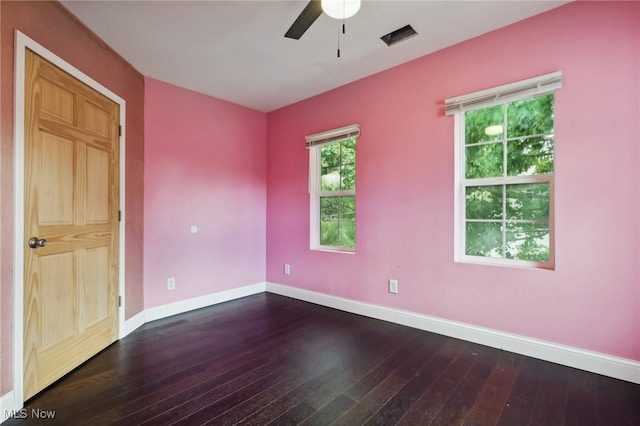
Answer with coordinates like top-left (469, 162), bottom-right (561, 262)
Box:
top-left (267, 2), bottom-right (640, 360)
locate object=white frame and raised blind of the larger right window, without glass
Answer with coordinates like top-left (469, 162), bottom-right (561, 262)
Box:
top-left (445, 71), bottom-right (562, 269)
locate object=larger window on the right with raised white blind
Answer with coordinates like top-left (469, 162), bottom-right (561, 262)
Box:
top-left (446, 73), bottom-right (562, 268)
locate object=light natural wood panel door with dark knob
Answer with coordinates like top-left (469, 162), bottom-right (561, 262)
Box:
top-left (24, 50), bottom-right (119, 400)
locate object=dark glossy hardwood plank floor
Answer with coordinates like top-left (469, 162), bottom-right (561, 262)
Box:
top-left (3, 294), bottom-right (640, 426)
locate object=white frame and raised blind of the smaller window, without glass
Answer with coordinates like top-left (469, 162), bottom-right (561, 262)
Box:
top-left (305, 124), bottom-right (360, 254)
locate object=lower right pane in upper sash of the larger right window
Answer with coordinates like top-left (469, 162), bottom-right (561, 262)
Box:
top-left (507, 136), bottom-right (553, 176)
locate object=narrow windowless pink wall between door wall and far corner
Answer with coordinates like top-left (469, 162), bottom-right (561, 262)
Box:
top-left (144, 78), bottom-right (266, 308)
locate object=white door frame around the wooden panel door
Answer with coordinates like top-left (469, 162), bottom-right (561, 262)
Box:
top-left (13, 31), bottom-right (126, 408)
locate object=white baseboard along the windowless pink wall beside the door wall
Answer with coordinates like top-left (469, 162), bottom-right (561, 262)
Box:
top-left (144, 282), bottom-right (266, 322)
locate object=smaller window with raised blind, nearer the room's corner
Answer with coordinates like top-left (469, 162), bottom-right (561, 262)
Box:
top-left (306, 125), bottom-right (360, 252)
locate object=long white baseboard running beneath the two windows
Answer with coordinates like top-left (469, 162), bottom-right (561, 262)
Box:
top-left (266, 282), bottom-right (640, 384)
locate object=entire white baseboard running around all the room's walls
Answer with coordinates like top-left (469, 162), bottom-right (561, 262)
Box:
top-left (0, 282), bottom-right (640, 423)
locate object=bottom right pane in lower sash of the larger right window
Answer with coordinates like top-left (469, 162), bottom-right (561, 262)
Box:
top-left (506, 223), bottom-right (549, 262)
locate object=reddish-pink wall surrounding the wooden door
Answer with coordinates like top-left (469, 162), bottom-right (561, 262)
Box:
top-left (0, 1), bottom-right (144, 396)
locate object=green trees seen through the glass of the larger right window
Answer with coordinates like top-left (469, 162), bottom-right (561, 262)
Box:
top-left (463, 94), bottom-right (554, 262)
